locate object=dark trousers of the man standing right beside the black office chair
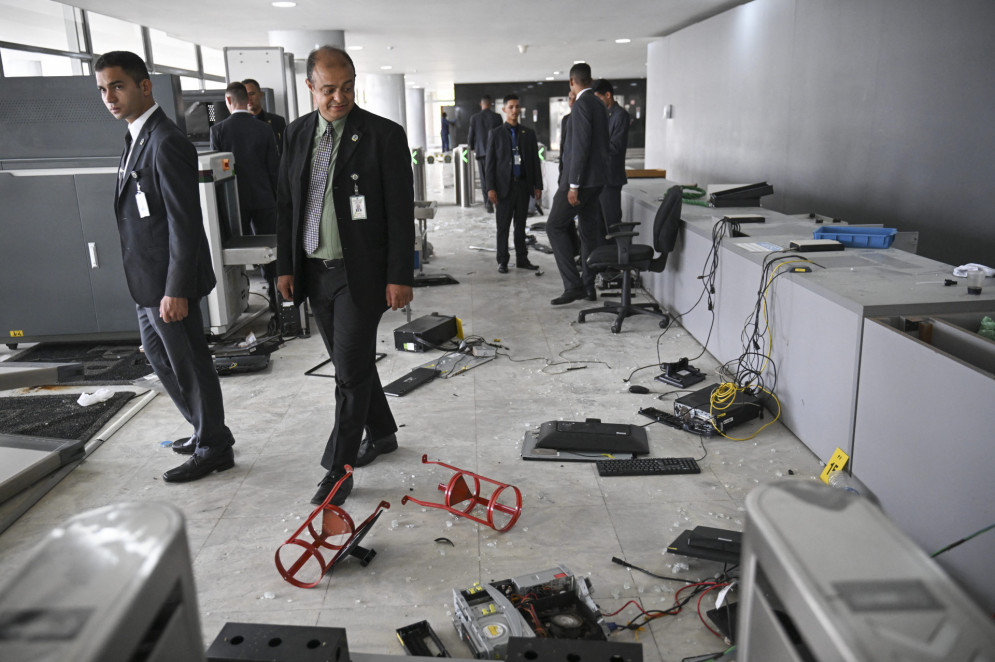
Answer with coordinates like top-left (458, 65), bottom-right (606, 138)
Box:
top-left (546, 185), bottom-right (605, 291)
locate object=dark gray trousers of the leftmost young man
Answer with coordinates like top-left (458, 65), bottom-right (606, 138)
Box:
top-left (137, 298), bottom-right (234, 457)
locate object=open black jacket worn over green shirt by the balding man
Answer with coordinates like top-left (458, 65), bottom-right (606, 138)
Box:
top-left (276, 106), bottom-right (415, 313)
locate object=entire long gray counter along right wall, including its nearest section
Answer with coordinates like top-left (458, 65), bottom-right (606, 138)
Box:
top-left (623, 180), bottom-right (995, 610)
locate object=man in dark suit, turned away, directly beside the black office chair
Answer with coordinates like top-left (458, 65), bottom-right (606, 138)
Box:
top-left (546, 62), bottom-right (608, 306)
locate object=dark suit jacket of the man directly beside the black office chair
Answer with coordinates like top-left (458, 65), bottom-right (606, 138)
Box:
top-left (560, 89), bottom-right (608, 188)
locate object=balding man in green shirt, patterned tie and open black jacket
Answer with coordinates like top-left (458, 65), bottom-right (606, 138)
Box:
top-left (277, 46), bottom-right (415, 505)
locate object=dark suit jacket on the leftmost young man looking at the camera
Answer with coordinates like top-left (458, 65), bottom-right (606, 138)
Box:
top-left (114, 108), bottom-right (216, 308)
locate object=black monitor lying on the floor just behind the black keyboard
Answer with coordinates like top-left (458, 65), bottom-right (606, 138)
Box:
top-left (522, 418), bottom-right (650, 462)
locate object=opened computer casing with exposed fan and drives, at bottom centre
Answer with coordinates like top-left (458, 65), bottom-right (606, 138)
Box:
top-left (453, 564), bottom-right (608, 660)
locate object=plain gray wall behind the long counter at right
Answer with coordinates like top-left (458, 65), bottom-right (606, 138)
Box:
top-left (646, 0), bottom-right (995, 266)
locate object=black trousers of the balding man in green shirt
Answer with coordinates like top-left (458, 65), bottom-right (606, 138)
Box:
top-left (307, 259), bottom-right (397, 471)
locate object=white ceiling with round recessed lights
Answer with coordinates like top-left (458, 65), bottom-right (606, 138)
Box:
top-left (72, 0), bottom-right (748, 90)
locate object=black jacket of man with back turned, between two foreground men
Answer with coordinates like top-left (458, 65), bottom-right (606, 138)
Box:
top-left (211, 112), bottom-right (280, 213)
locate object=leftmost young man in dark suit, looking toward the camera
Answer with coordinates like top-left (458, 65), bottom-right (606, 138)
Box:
top-left (94, 51), bottom-right (235, 483)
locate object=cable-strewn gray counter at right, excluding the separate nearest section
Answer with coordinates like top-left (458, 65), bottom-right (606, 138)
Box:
top-left (622, 180), bottom-right (995, 460)
